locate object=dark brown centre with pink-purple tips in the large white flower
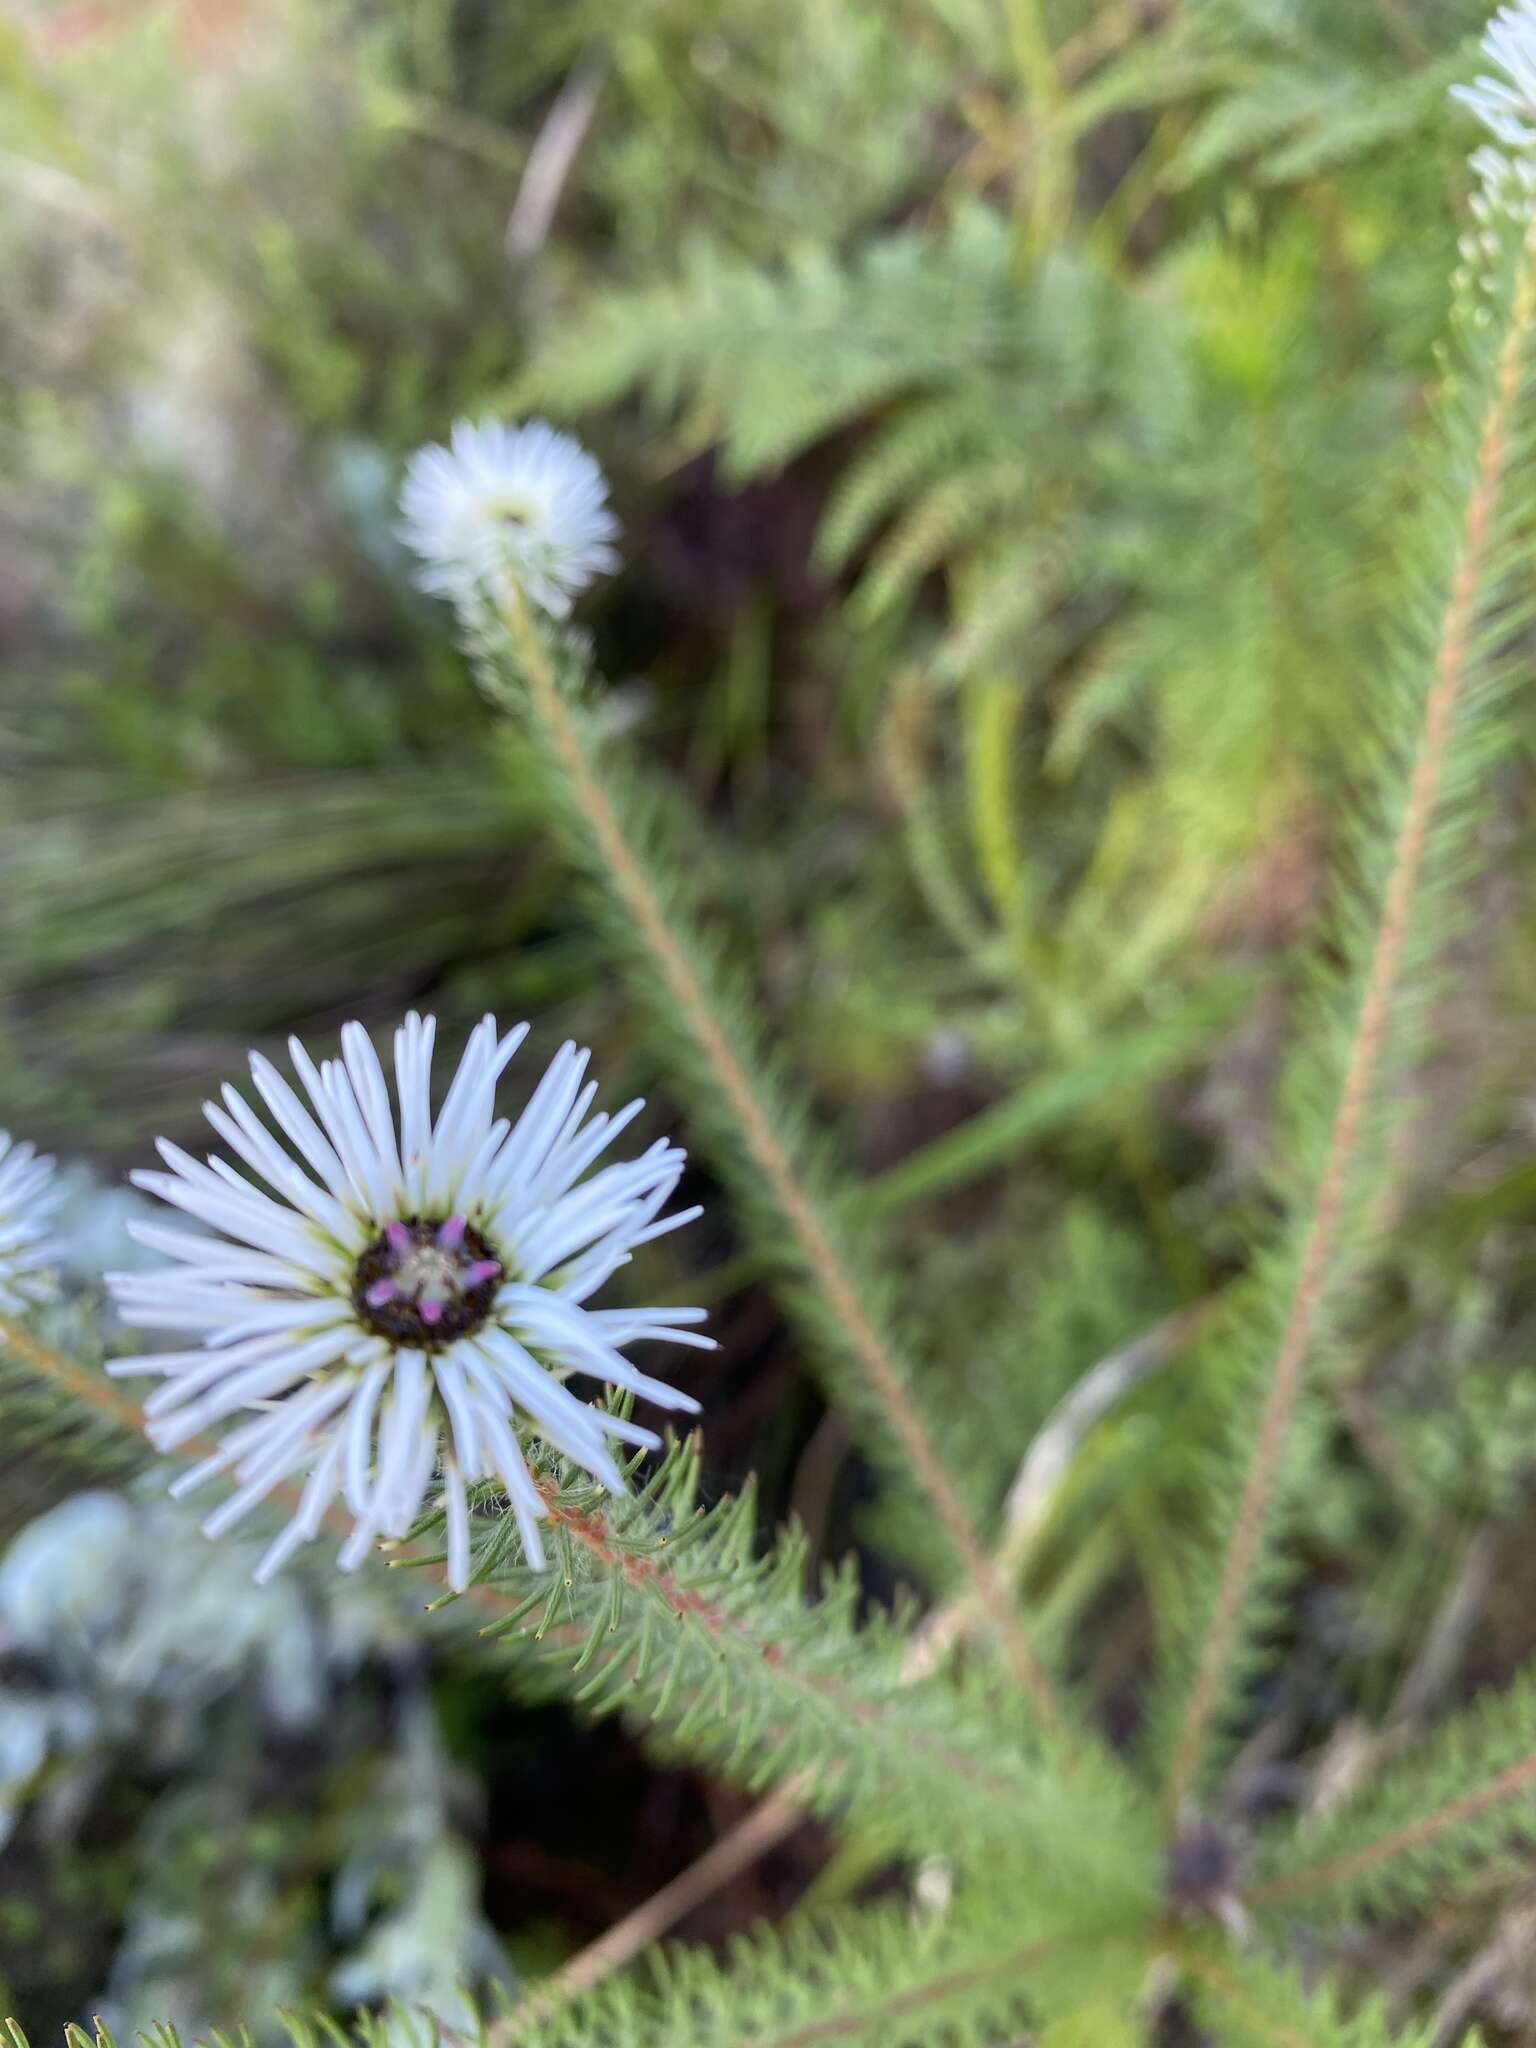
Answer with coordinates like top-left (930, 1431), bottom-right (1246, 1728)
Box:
top-left (352, 1217), bottom-right (504, 1352)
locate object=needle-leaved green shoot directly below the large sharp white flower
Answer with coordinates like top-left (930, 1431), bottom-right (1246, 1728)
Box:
top-left (450, 1444), bottom-right (1153, 1896)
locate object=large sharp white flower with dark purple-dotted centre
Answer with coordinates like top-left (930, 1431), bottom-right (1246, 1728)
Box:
top-left (109, 1014), bottom-right (713, 1591)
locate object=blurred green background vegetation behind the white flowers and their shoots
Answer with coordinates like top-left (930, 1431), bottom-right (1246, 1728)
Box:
top-left (0, 0), bottom-right (1536, 2040)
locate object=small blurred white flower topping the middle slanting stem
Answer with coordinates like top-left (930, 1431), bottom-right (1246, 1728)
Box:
top-left (399, 420), bottom-right (618, 618)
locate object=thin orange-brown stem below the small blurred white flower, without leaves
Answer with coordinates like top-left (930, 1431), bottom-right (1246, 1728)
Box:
top-left (506, 592), bottom-right (1069, 1741)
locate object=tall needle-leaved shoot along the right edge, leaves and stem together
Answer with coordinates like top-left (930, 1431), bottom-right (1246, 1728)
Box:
top-left (1171, 136), bottom-right (1536, 1800)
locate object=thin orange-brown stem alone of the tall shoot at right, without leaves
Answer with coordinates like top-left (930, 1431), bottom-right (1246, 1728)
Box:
top-left (1167, 242), bottom-right (1536, 1815)
